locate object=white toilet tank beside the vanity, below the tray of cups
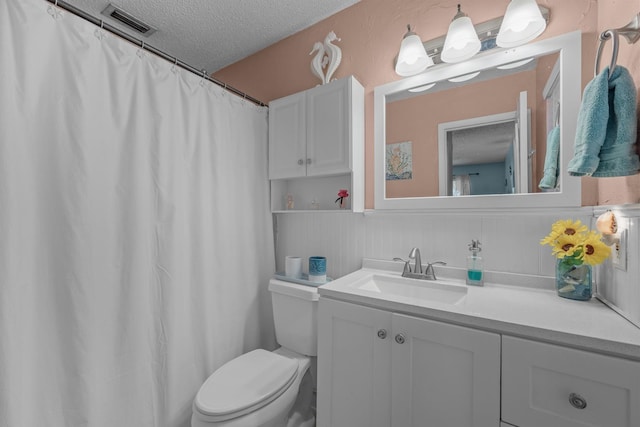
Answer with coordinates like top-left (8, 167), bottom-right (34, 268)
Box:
top-left (269, 279), bottom-right (319, 356)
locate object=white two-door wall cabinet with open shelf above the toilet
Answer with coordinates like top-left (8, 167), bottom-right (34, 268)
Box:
top-left (269, 76), bottom-right (364, 211)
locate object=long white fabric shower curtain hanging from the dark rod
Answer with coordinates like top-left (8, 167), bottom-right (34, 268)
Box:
top-left (0, 0), bottom-right (275, 427)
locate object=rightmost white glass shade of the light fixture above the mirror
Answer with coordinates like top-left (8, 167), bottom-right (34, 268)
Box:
top-left (496, 0), bottom-right (547, 47)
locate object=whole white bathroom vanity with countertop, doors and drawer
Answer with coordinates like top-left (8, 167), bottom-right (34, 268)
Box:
top-left (318, 260), bottom-right (640, 427)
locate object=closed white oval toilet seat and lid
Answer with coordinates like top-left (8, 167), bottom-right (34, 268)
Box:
top-left (194, 349), bottom-right (298, 421)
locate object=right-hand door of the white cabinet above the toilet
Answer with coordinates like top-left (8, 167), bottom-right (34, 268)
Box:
top-left (307, 78), bottom-right (352, 176)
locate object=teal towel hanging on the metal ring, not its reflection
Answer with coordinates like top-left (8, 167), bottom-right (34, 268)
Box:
top-left (568, 65), bottom-right (640, 177)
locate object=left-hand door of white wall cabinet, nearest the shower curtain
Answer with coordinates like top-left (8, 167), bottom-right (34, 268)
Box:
top-left (269, 92), bottom-right (307, 179)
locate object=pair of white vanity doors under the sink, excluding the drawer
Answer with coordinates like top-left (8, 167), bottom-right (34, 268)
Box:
top-left (318, 298), bottom-right (500, 427)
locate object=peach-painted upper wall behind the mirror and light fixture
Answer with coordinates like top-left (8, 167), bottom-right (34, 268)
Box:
top-left (214, 0), bottom-right (608, 208)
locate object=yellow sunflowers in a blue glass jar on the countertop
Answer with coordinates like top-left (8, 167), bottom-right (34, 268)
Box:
top-left (540, 220), bottom-right (611, 301)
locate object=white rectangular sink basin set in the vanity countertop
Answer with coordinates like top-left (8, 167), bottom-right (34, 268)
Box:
top-left (350, 274), bottom-right (467, 305)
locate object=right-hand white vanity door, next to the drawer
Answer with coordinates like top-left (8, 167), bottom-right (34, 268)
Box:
top-left (391, 314), bottom-right (500, 427)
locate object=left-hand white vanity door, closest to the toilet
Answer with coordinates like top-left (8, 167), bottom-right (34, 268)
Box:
top-left (317, 298), bottom-right (392, 427)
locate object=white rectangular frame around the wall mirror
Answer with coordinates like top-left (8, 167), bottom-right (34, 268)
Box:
top-left (374, 31), bottom-right (582, 210)
